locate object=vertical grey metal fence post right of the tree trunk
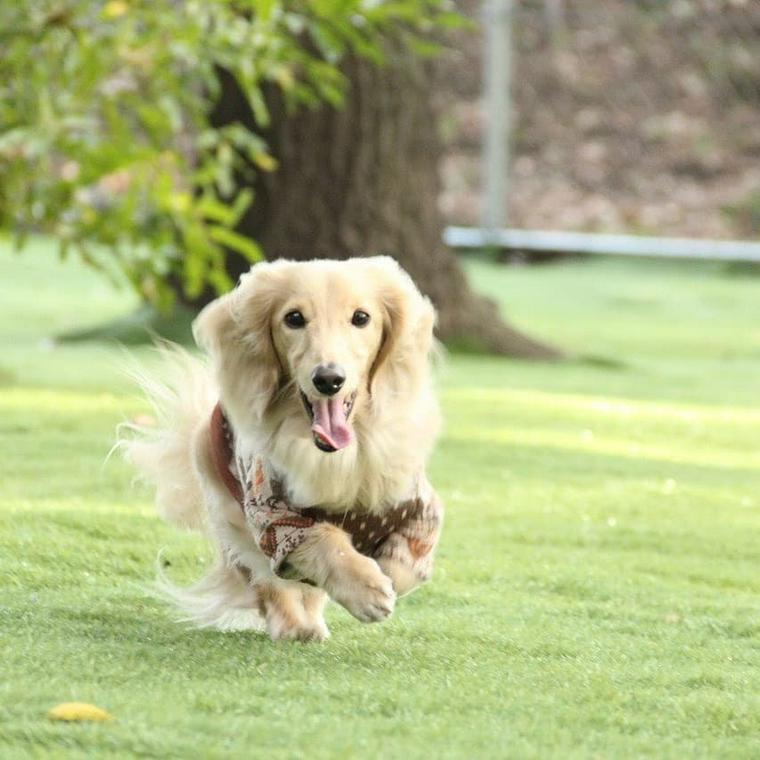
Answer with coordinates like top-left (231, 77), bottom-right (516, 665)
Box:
top-left (482, 0), bottom-right (512, 239)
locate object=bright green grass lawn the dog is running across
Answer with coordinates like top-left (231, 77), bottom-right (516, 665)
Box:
top-left (0, 242), bottom-right (760, 758)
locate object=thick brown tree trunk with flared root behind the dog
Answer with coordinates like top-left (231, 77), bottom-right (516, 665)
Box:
top-left (208, 53), bottom-right (561, 359)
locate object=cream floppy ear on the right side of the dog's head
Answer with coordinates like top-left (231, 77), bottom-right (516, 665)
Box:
top-left (367, 256), bottom-right (436, 391)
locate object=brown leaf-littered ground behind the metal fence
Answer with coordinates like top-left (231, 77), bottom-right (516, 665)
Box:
top-left (441, 0), bottom-right (760, 238)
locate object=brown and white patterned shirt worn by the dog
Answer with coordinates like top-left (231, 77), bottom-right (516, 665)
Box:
top-left (210, 404), bottom-right (443, 580)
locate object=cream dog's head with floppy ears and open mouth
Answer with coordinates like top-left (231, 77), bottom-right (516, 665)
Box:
top-left (193, 256), bottom-right (435, 452)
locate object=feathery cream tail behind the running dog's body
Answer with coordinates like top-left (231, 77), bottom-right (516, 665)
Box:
top-left (116, 343), bottom-right (218, 529)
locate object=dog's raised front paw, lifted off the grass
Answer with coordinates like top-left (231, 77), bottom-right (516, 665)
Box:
top-left (327, 554), bottom-right (396, 623)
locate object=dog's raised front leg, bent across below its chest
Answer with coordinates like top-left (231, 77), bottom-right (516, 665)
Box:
top-left (288, 523), bottom-right (396, 623)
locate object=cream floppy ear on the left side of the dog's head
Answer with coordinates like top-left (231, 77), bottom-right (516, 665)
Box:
top-left (193, 263), bottom-right (281, 425)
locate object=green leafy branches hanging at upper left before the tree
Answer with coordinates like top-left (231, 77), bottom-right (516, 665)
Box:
top-left (0, 0), bottom-right (455, 305)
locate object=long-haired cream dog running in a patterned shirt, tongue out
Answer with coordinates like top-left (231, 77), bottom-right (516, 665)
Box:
top-left (123, 257), bottom-right (442, 641)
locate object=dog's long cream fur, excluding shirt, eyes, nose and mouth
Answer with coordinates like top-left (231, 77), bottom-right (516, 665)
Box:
top-left (121, 257), bottom-right (439, 640)
